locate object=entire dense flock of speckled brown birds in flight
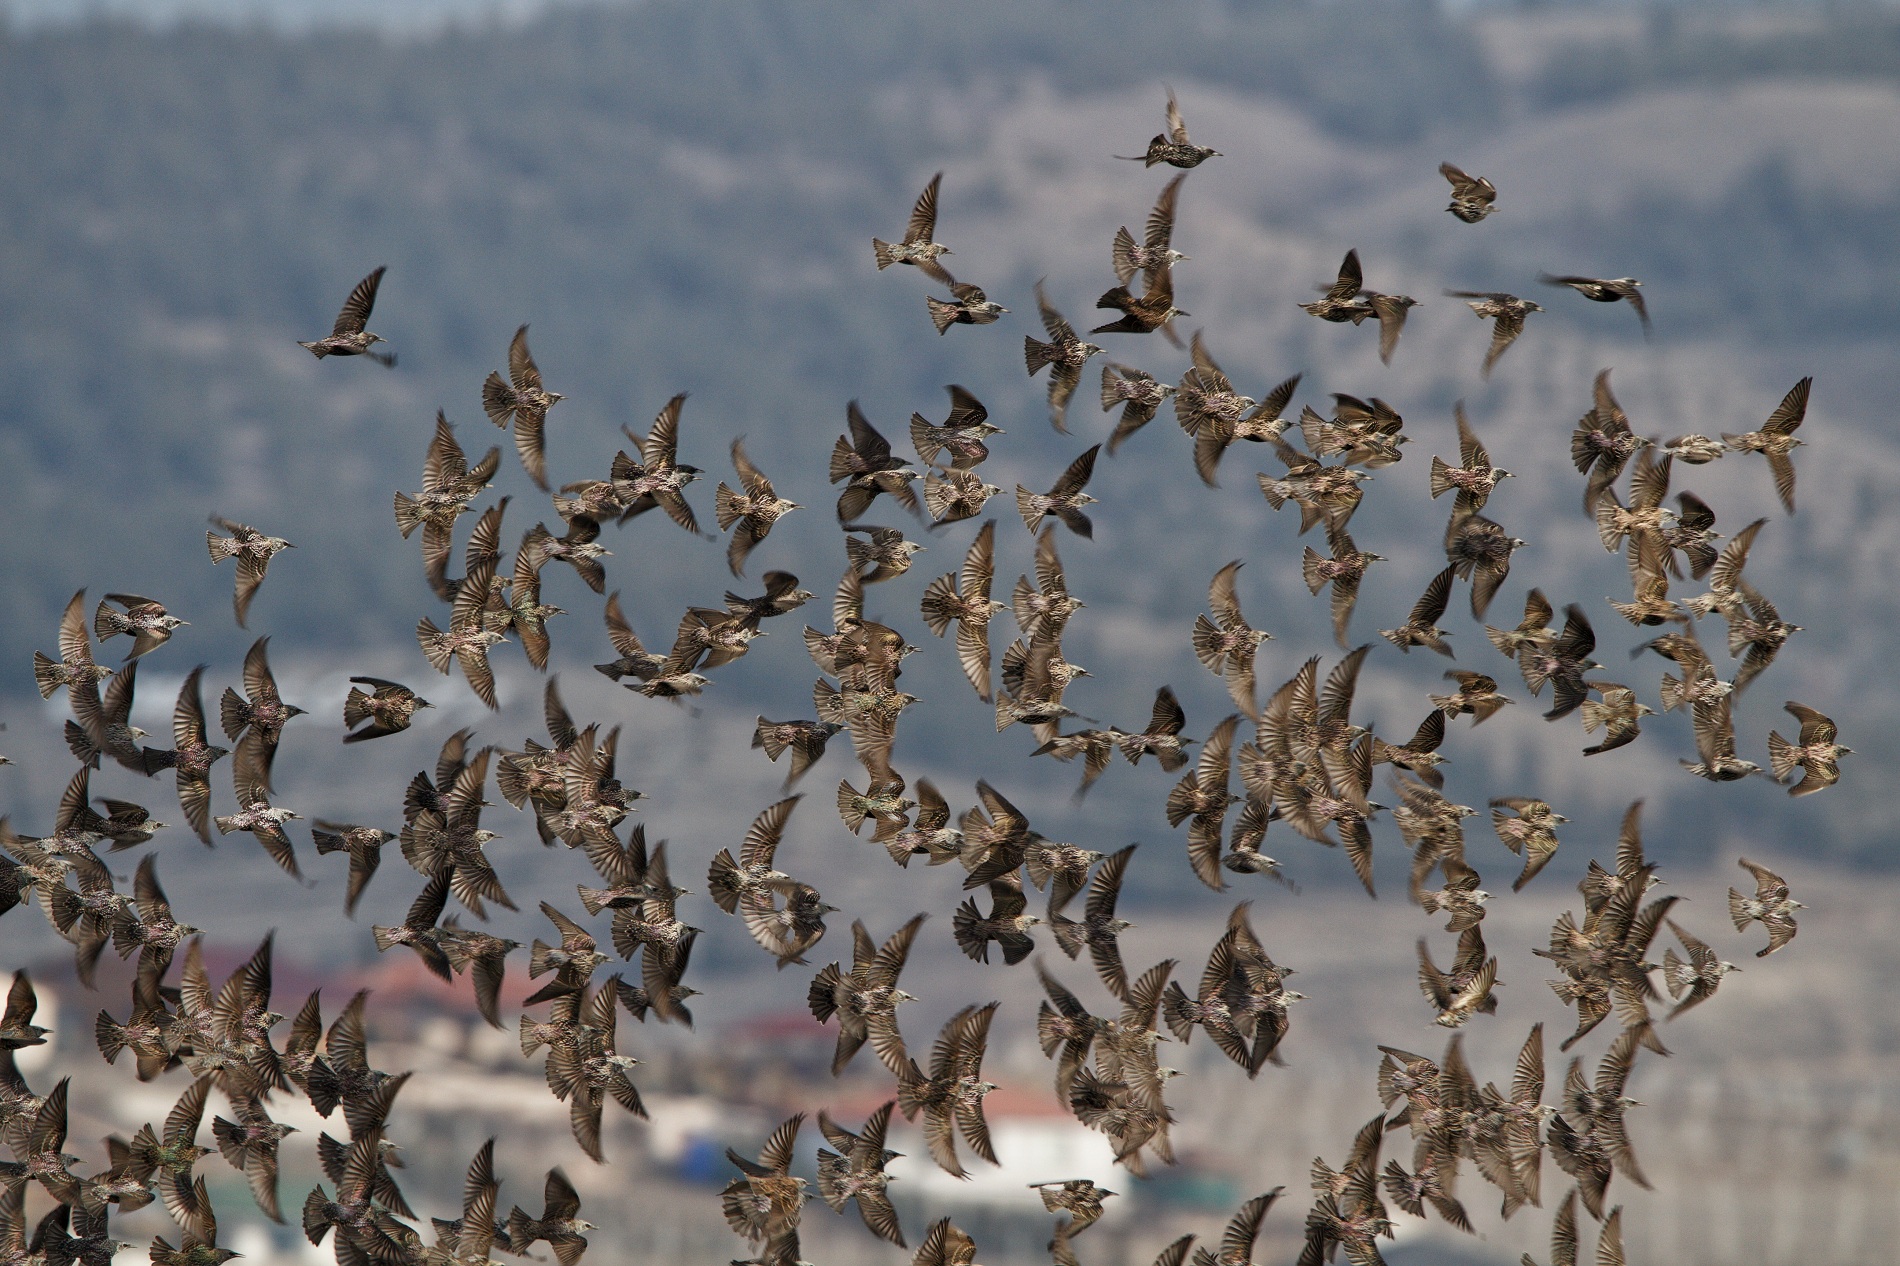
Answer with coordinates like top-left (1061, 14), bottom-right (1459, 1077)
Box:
top-left (0, 95), bottom-right (1847, 1266)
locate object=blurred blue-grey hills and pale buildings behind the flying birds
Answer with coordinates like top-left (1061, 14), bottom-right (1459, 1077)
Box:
top-left (0, 0), bottom-right (1900, 1266)
